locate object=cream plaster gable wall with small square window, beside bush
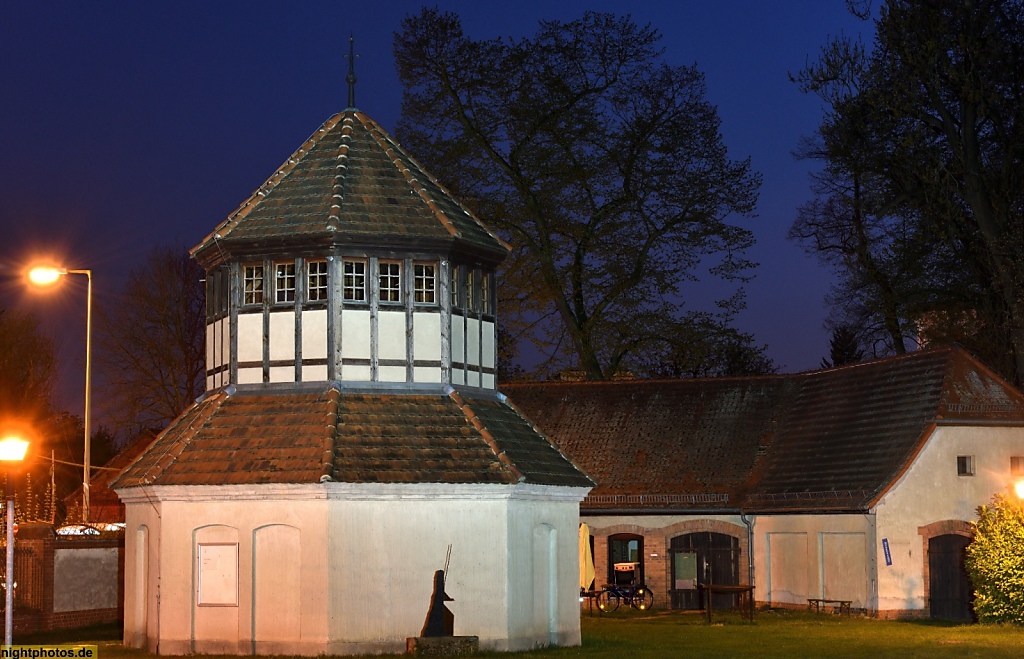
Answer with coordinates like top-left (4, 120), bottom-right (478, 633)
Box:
top-left (874, 426), bottom-right (1024, 610)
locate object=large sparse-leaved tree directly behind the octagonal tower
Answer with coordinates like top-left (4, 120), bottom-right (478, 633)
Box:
top-left (394, 9), bottom-right (760, 380)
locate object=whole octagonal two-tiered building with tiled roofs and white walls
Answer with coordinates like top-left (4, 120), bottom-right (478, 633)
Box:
top-left (112, 76), bottom-right (593, 655)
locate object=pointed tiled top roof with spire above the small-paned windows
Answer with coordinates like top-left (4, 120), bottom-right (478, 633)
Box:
top-left (193, 109), bottom-right (508, 262)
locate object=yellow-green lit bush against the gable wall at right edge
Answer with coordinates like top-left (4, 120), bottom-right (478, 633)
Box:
top-left (966, 494), bottom-right (1024, 624)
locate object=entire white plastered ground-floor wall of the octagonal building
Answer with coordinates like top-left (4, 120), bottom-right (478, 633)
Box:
top-left (119, 483), bottom-right (587, 655)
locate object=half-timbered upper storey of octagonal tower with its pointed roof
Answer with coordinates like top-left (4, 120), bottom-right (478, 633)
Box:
top-left (193, 109), bottom-right (508, 390)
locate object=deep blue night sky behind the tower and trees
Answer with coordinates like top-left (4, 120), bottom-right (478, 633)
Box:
top-left (0, 0), bottom-right (869, 411)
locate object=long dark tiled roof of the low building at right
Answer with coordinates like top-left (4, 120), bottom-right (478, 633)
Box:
top-left (504, 347), bottom-right (1024, 512)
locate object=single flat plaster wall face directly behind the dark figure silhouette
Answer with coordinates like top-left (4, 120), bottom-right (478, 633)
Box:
top-left (328, 491), bottom-right (508, 654)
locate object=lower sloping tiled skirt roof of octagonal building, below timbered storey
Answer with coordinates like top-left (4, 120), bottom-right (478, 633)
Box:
top-left (113, 386), bottom-right (593, 488)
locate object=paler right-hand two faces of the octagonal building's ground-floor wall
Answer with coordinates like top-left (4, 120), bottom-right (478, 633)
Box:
top-left (328, 483), bottom-right (586, 654)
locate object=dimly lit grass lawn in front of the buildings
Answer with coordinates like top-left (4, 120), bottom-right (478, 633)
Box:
top-left (14, 610), bottom-right (1024, 659)
